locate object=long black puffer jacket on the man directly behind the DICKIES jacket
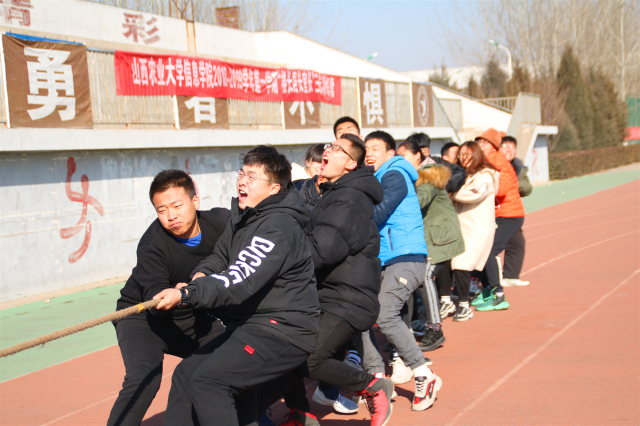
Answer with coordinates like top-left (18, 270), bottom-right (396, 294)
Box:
top-left (309, 167), bottom-right (384, 331)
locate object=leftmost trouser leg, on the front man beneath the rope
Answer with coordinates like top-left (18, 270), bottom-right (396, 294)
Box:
top-left (107, 314), bottom-right (168, 426)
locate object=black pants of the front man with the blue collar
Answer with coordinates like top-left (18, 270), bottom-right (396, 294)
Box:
top-left (107, 313), bottom-right (224, 426)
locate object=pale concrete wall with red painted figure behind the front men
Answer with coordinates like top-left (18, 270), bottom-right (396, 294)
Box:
top-left (0, 141), bottom-right (308, 302)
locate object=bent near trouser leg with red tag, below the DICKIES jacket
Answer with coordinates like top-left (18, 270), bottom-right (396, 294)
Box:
top-left (190, 325), bottom-right (308, 426)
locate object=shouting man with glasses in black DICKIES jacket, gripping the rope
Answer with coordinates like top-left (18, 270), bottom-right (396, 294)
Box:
top-left (155, 146), bottom-right (320, 426)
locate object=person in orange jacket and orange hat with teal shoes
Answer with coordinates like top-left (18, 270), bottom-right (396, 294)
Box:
top-left (472, 128), bottom-right (524, 311)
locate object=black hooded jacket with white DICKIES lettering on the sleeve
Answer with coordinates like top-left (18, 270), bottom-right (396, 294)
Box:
top-left (187, 190), bottom-right (320, 352)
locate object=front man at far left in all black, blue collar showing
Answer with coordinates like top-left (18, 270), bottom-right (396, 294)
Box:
top-left (107, 170), bottom-right (231, 426)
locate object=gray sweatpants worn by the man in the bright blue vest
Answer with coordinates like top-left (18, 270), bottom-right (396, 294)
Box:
top-left (361, 262), bottom-right (427, 374)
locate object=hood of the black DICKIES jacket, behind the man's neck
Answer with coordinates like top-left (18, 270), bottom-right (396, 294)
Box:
top-left (231, 187), bottom-right (311, 229)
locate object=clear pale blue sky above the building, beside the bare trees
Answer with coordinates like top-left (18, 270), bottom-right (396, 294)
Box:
top-left (311, 0), bottom-right (470, 71)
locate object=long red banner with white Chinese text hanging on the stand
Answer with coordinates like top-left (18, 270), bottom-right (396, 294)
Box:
top-left (115, 50), bottom-right (342, 105)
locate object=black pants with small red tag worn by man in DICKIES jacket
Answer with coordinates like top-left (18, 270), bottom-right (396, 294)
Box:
top-left (164, 325), bottom-right (309, 426)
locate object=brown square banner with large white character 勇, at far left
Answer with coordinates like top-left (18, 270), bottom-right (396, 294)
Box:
top-left (2, 35), bottom-right (93, 128)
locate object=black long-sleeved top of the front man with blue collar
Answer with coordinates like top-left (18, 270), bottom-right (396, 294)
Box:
top-left (116, 208), bottom-right (231, 331)
